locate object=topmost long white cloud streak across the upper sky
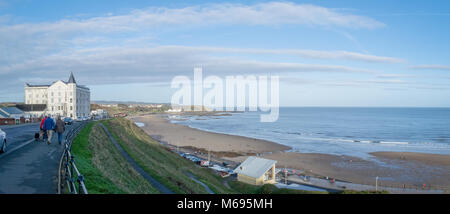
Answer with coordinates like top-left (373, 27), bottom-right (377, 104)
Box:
top-left (3, 2), bottom-right (385, 33)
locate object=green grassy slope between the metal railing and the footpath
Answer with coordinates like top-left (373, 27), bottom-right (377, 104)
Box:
top-left (72, 122), bottom-right (158, 194)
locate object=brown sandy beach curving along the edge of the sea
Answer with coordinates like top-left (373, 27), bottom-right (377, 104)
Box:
top-left (130, 115), bottom-right (450, 191)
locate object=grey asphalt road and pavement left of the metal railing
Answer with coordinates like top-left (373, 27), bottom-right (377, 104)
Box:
top-left (0, 123), bottom-right (80, 194)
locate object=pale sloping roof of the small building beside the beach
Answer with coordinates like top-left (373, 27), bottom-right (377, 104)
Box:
top-left (234, 156), bottom-right (277, 178)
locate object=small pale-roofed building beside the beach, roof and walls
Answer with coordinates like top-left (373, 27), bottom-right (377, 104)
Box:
top-left (234, 156), bottom-right (277, 185)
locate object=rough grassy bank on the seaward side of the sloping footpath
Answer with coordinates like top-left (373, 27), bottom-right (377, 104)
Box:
top-left (103, 118), bottom-right (238, 194)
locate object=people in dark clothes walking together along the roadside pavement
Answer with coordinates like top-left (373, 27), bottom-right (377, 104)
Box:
top-left (39, 116), bottom-right (66, 145)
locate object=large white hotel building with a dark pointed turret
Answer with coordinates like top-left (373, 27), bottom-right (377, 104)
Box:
top-left (25, 73), bottom-right (91, 119)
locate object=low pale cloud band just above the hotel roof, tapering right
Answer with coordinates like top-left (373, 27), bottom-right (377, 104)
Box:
top-left (0, 46), bottom-right (372, 79)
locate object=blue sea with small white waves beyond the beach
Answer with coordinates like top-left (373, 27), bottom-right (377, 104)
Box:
top-left (171, 107), bottom-right (450, 158)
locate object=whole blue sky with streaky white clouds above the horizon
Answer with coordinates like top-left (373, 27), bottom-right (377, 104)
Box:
top-left (0, 0), bottom-right (450, 107)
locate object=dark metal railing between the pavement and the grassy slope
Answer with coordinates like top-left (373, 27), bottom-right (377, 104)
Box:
top-left (58, 122), bottom-right (88, 194)
